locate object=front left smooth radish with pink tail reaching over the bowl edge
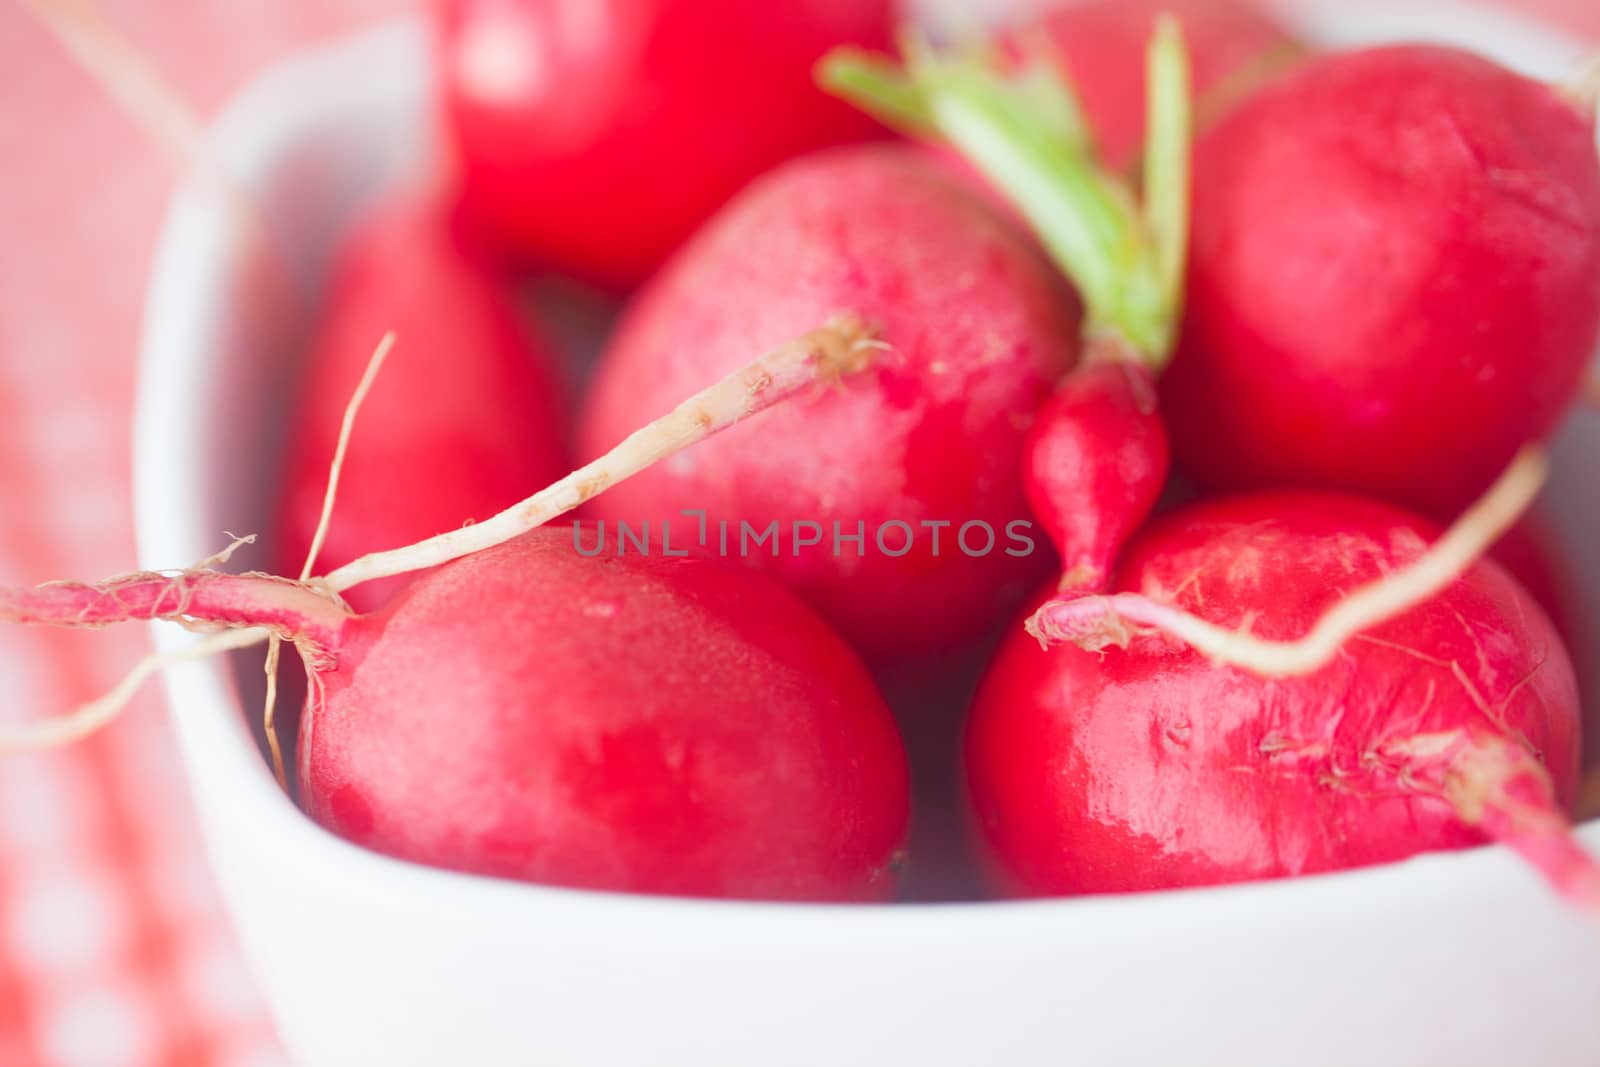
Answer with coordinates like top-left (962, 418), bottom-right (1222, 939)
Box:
top-left (0, 530), bottom-right (909, 901)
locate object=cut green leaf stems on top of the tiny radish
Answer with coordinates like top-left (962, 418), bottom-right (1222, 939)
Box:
top-left (818, 16), bottom-right (1194, 364)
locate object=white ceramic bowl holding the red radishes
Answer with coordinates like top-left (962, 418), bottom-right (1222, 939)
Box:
top-left (136, 5), bottom-right (1600, 1067)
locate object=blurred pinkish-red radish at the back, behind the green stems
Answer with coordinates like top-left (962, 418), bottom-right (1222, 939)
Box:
top-left (1008, 0), bottom-right (1302, 171)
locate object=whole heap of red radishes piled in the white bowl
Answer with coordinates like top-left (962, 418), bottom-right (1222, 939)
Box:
top-left (9, 0), bottom-right (1600, 910)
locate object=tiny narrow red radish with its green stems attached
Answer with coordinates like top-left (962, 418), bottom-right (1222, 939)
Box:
top-left (822, 18), bottom-right (1192, 592)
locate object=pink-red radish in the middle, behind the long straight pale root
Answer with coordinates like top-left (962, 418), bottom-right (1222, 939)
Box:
top-left (579, 146), bottom-right (1078, 662)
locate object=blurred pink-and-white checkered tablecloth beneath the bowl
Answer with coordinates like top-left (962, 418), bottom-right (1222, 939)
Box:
top-left (0, 0), bottom-right (1600, 1067)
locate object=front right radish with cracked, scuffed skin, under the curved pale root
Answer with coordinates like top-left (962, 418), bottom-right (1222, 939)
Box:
top-left (966, 493), bottom-right (1600, 907)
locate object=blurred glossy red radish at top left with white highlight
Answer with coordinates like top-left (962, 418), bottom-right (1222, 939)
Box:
top-left (437, 0), bottom-right (894, 286)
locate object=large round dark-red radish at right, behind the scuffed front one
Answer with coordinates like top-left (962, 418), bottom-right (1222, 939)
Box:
top-left (1163, 46), bottom-right (1600, 514)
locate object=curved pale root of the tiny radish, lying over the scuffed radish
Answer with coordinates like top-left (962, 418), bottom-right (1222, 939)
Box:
top-left (1027, 446), bottom-right (1550, 678)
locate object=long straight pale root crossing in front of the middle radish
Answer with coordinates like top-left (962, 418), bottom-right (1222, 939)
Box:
top-left (317, 314), bottom-right (882, 592)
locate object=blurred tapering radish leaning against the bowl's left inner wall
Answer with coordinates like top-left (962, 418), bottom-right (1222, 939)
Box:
top-left (277, 191), bottom-right (571, 609)
